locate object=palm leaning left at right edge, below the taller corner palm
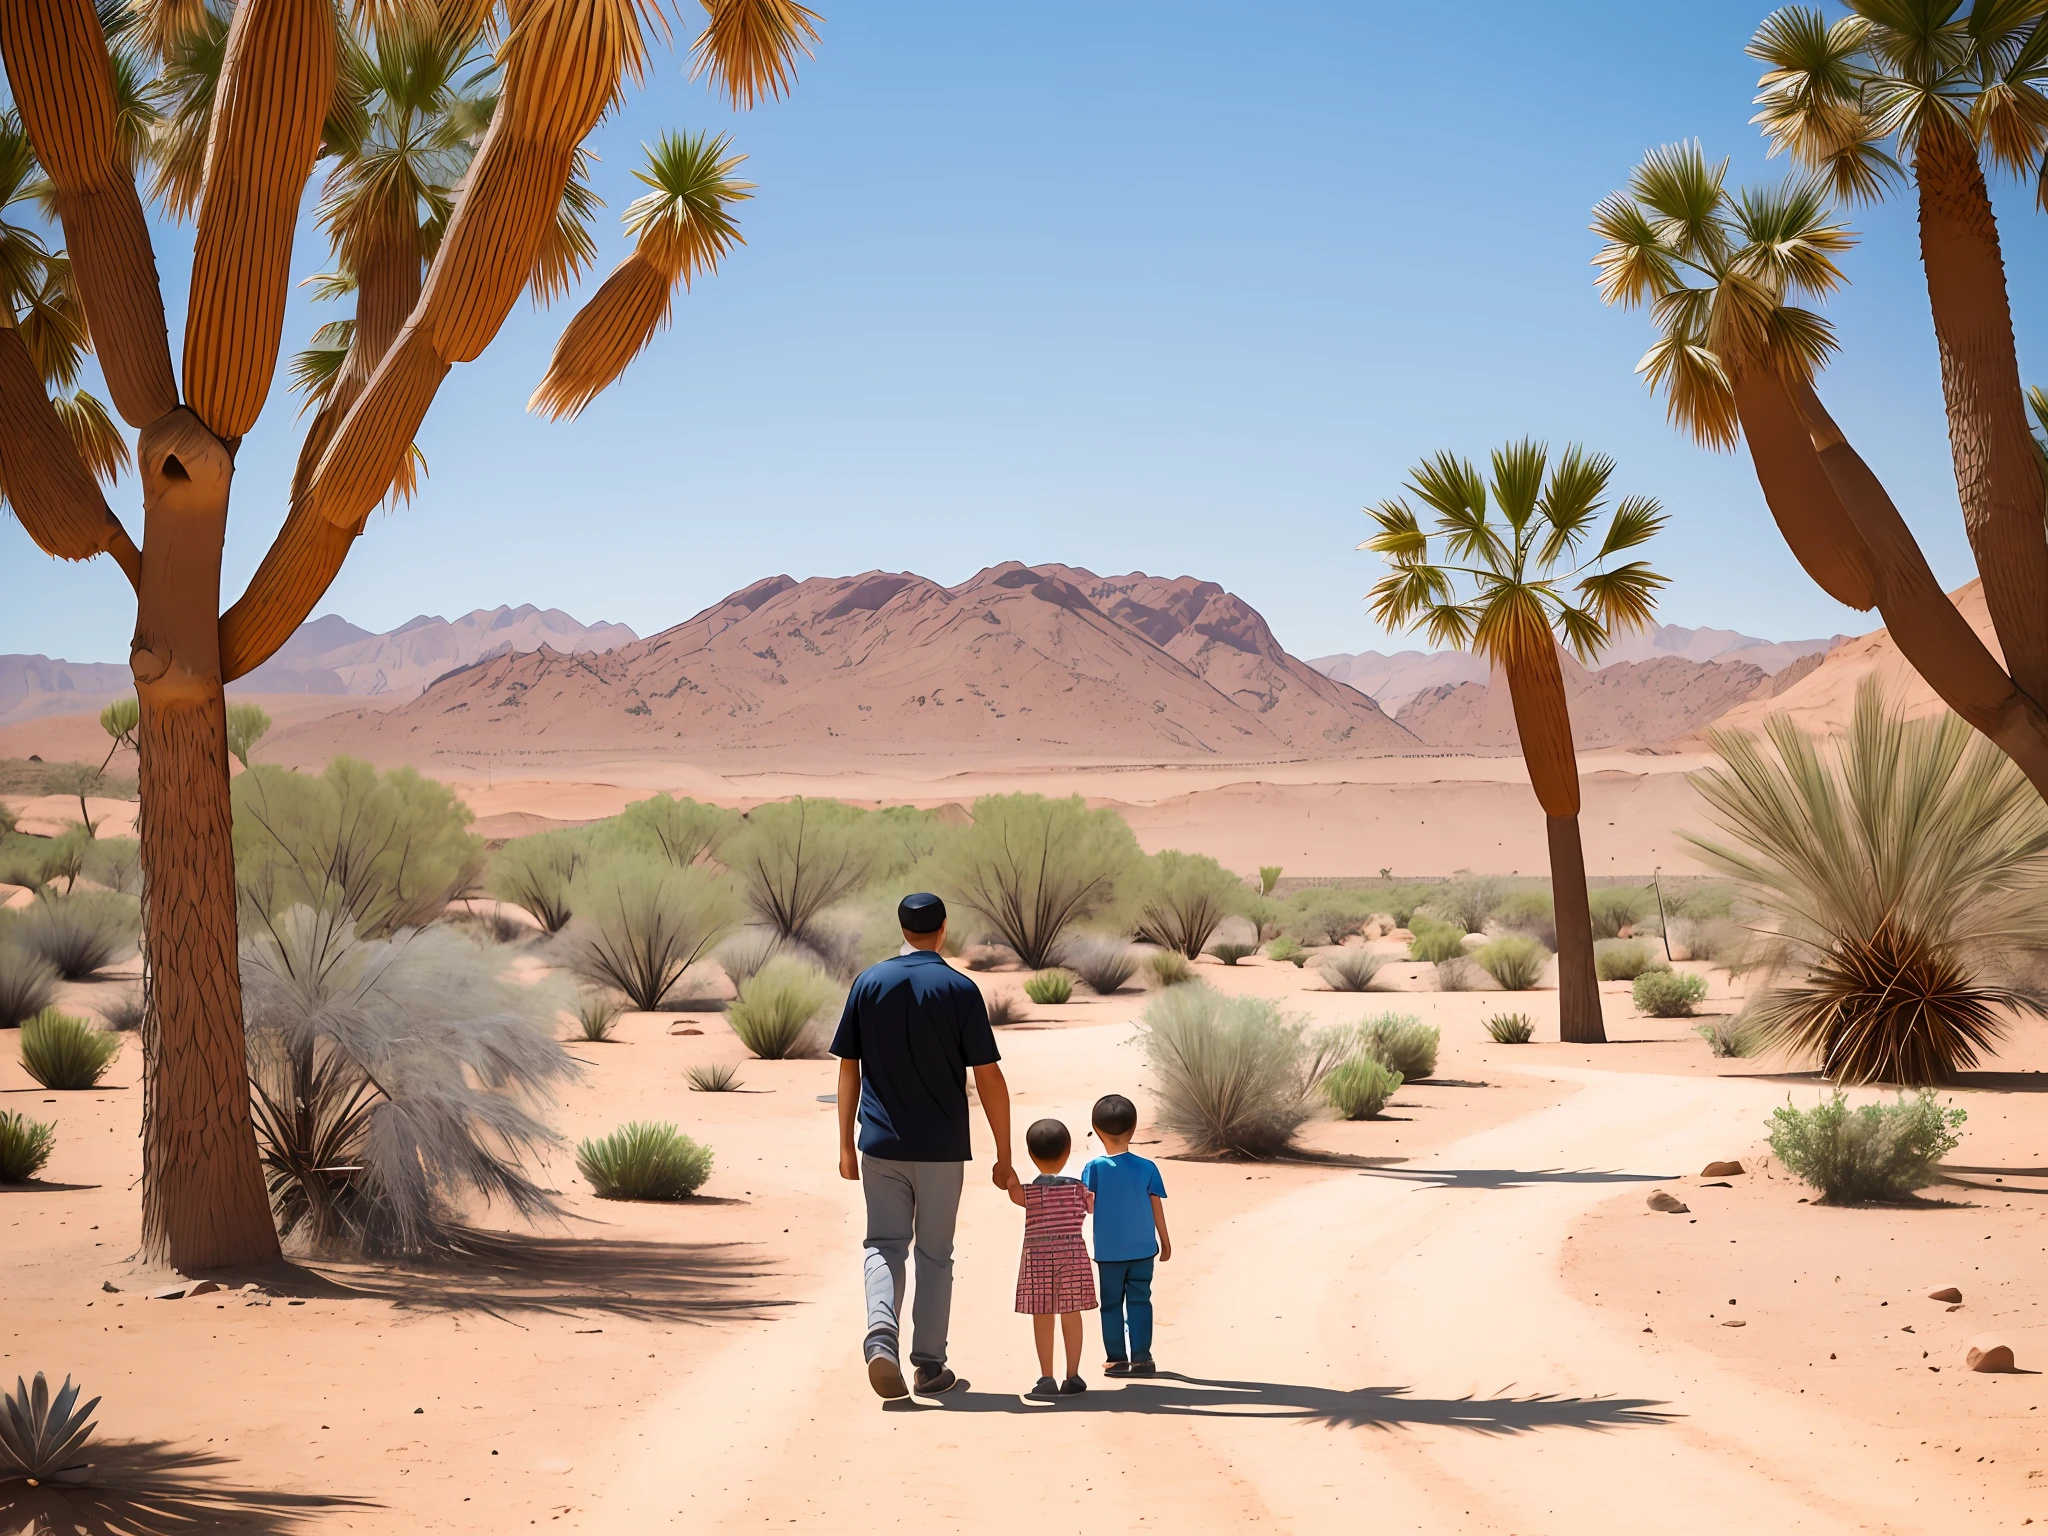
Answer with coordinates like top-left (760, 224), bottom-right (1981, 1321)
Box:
top-left (1593, 143), bottom-right (2048, 797)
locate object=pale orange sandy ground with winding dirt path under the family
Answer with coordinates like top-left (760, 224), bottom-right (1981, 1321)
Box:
top-left (0, 961), bottom-right (2048, 1536)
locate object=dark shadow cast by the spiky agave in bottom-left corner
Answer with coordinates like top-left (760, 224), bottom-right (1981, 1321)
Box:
top-left (0, 1440), bottom-right (379, 1536)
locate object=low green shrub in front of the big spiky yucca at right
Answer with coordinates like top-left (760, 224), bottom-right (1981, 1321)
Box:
top-left (1772, 1087), bottom-right (1968, 1204)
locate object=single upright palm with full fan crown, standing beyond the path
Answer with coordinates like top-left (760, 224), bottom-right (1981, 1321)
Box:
top-left (1360, 440), bottom-right (1665, 1042)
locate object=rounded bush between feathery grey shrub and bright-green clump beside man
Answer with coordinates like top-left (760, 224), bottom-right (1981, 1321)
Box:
top-left (569, 854), bottom-right (739, 1012)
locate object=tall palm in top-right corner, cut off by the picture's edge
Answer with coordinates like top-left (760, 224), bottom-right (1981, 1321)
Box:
top-left (1749, 0), bottom-right (2048, 702)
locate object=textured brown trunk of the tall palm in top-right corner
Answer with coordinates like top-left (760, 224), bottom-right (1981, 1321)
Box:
top-left (1913, 131), bottom-right (2048, 700)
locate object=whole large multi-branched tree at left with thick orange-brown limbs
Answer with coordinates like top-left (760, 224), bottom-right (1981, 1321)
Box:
top-left (0, 0), bottom-right (817, 1268)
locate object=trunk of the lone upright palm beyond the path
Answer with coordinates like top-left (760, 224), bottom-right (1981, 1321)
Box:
top-left (1501, 631), bottom-right (1608, 1044)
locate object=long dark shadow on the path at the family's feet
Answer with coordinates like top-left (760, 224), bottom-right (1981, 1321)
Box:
top-left (911, 1370), bottom-right (1677, 1436)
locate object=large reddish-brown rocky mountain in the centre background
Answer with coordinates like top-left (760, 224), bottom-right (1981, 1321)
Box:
top-left (266, 563), bottom-right (1417, 770)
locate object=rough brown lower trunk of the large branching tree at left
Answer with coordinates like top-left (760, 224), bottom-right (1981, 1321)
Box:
top-left (129, 410), bottom-right (279, 1270)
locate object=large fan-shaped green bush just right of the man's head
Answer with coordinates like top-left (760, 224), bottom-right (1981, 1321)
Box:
top-left (934, 795), bottom-right (1145, 971)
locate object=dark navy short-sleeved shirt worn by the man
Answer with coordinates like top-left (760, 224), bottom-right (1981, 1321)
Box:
top-left (831, 950), bottom-right (1001, 1163)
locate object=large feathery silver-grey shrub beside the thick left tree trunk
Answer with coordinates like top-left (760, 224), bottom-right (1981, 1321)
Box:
top-left (242, 907), bottom-right (578, 1253)
